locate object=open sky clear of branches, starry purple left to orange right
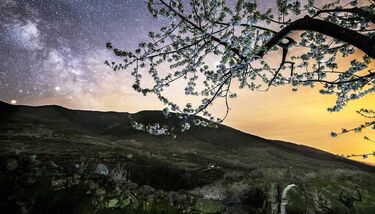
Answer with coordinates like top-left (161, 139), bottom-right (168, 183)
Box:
top-left (0, 0), bottom-right (375, 163)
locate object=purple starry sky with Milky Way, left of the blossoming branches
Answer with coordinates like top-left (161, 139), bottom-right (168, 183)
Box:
top-left (0, 0), bottom-right (166, 103)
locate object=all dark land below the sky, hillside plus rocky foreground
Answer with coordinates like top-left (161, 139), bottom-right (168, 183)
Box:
top-left (0, 102), bottom-right (375, 213)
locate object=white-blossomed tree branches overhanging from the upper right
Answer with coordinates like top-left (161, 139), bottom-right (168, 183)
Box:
top-left (106, 0), bottom-right (375, 155)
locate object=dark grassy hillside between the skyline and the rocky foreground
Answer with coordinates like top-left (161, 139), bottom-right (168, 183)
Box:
top-left (0, 103), bottom-right (375, 213)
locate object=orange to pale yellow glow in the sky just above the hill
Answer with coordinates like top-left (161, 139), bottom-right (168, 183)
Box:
top-left (21, 23), bottom-right (375, 164)
